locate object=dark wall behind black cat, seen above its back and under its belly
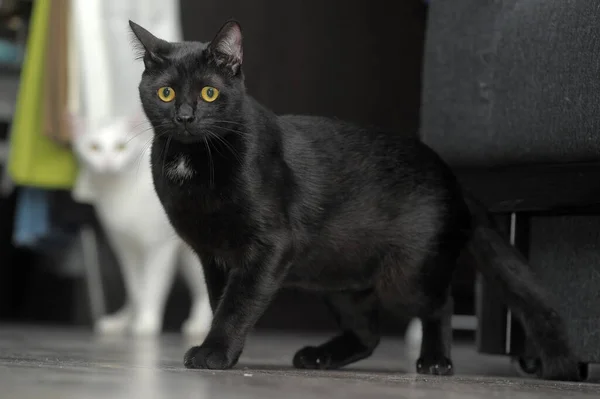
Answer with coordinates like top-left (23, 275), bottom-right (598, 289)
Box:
top-left (176, 0), bottom-right (426, 331)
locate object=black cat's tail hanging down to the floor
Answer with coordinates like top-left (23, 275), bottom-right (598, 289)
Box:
top-left (466, 195), bottom-right (584, 381)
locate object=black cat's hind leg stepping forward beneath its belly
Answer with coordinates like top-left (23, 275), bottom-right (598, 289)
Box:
top-left (294, 290), bottom-right (380, 369)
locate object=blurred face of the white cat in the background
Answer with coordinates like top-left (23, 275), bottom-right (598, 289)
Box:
top-left (73, 115), bottom-right (149, 173)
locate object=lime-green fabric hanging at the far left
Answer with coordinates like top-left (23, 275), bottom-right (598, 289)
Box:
top-left (8, 1), bottom-right (77, 189)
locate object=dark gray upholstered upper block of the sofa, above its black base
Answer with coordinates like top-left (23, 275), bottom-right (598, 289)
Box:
top-left (421, 0), bottom-right (600, 167)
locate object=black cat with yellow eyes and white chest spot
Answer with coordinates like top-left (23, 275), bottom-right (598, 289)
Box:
top-left (130, 21), bottom-right (580, 380)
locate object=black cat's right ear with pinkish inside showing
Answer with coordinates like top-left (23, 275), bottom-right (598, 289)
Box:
top-left (207, 20), bottom-right (244, 75)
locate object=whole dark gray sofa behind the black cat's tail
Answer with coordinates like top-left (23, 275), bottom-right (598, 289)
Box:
top-left (421, 0), bottom-right (600, 371)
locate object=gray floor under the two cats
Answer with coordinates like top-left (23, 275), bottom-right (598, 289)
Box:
top-left (0, 327), bottom-right (600, 399)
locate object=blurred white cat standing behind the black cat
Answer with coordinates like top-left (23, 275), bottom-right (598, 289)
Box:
top-left (73, 113), bottom-right (212, 337)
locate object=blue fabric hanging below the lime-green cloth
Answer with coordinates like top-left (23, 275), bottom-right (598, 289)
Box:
top-left (13, 187), bottom-right (50, 248)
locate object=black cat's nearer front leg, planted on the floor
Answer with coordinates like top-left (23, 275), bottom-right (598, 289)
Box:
top-left (184, 245), bottom-right (290, 370)
